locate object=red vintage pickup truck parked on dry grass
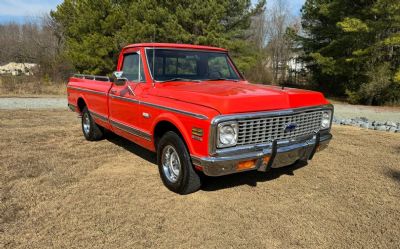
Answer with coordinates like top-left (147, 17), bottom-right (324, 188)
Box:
top-left (67, 43), bottom-right (333, 194)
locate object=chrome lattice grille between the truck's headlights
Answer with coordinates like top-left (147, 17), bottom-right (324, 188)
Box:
top-left (237, 111), bottom-right (322, 145)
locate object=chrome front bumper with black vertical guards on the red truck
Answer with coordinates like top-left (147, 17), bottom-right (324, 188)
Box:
top-left (192, 132), bottom-right (332, 176)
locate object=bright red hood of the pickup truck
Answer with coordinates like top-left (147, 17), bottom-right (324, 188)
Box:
top-left (152, 81), bottom-right (329, 114)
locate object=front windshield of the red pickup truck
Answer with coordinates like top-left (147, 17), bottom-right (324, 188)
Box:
top-left (146, 48), bottom-right (241, 82)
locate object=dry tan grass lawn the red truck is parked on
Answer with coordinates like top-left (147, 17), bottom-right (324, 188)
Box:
top-left (0, 110), bottom-right (400, 248)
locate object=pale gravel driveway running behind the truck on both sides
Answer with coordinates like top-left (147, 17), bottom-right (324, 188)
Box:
top-left (0, 97), bottom-right (400, 122)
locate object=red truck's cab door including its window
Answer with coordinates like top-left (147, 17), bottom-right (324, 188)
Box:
top-left (109, 49), bottom-right (145, 142)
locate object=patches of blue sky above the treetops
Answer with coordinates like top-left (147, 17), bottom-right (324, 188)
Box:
top-left (0, 0), bottom-right (305, 23)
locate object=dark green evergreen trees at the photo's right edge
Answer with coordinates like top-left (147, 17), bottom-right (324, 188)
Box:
top-left (300, 0), bottom-right (400, 104)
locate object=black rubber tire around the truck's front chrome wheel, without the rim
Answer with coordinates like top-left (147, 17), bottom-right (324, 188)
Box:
top-left (157, 131), bottom-right (201, 195)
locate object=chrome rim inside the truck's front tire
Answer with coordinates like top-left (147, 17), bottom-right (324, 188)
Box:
top-left (161, 145), bottom-right (181, 183)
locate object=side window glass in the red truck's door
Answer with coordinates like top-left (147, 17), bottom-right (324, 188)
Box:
top-left (122, 53), bottom-right (144, 82)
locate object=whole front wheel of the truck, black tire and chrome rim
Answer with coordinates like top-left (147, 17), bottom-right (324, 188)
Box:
top-left (157, 131), bottom-right (201, 194)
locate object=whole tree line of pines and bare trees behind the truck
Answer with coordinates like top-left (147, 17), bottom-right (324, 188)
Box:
top-left (0, 0), bottom-right (400, 105)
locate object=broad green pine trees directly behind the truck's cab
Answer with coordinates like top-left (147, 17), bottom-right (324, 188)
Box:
top-left (51, 0), bottom-right (265, 74)
